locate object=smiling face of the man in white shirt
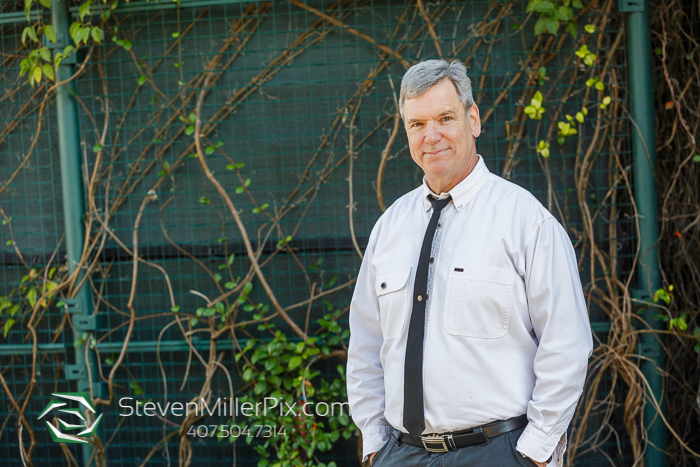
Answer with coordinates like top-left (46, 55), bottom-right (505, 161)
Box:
top-left (403, 79), bottom-right (481, 193)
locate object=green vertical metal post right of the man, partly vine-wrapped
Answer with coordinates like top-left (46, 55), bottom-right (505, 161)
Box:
top-left (620, 0), bottom-right (667, 467)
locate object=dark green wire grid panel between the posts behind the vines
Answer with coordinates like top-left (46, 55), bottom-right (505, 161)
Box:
top-left (0, 1), bottom-right (634, 465)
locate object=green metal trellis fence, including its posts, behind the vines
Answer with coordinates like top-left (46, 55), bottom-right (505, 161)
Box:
top-left (0, 0), bottom-right (665, 465)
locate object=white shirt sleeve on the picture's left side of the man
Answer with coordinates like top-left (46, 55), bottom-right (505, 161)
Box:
top-left (347, 229), bottom-right (393, 461)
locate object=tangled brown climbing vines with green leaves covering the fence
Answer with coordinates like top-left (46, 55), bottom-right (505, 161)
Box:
top-left (0, 0), bottom-right (700, 467)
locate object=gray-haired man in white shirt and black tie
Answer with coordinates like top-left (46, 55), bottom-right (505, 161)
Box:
top-left (347, 60), bottom-right (592, 467)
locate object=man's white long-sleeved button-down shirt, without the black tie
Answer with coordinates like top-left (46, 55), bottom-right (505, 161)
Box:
top-left (347, 156), bottom-right (593, 465)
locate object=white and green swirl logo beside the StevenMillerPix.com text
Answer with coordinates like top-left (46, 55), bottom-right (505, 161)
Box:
top-left (39, 392), bottom-right (102, 444)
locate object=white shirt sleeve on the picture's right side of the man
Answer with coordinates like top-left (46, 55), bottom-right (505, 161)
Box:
top-left (517, 217), bottom-right (593, 466)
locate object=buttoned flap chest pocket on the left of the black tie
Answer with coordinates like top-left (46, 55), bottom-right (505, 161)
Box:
top-left (375, 268), bottom-right (411, 340)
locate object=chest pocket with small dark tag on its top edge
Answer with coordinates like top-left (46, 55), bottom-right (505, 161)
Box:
top-left (443, 265), bottom-right (513, 339)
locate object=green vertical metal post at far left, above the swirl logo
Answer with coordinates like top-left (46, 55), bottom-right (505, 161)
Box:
top-left (50, 0), bottom-right (103, 466)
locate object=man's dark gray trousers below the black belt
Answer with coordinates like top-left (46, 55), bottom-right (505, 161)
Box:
top-left (372, 428), bottom-right (537, 467)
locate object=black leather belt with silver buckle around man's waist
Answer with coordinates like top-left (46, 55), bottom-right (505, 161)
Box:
top-left (393, 415), bottom-right (527, 452)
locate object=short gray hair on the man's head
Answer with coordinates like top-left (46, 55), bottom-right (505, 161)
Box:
top-left (399, 60), bottom-right (475, 119)
